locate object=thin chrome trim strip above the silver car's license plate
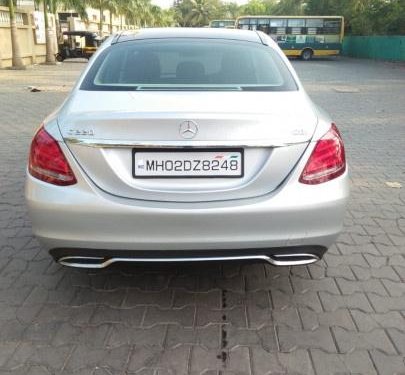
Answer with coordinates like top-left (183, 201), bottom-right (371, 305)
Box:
top-left (64, 137), bottom-right (308, 148)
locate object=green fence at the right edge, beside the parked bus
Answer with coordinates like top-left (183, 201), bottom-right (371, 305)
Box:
top-left (343, 35), bottom-right (405, 61)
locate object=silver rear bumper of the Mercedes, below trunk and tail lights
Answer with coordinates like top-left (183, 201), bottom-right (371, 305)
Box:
top-left (26, 162), bottom-right (349, 259)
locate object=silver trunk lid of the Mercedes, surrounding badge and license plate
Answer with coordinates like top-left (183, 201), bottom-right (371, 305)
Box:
top-left (58, 91), bottom-right (317, 202)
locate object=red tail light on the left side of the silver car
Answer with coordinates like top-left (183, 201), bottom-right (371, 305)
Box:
top-left (28, 127), bottom-right (77, 186)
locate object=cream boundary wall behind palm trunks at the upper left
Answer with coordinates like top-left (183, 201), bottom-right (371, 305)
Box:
top-left (0, 7), bottom-right (46, 68)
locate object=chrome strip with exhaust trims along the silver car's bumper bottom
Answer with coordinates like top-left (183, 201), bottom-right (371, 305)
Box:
top-left (58, 254), bottom-right (319, 269)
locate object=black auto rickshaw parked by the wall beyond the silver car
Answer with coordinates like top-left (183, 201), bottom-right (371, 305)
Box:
top-left (55, 31), bottom-right (101, 61)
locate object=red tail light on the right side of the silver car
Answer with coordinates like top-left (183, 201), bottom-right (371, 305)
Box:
top-left (299, 124), bottom-right (346, 185)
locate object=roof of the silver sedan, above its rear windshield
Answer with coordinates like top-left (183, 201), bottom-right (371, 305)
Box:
top-left (111, 27), bottom-right (263, 44)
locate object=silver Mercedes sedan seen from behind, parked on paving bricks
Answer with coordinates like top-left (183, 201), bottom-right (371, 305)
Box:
top-left (25, 28), bottom-right (349, 268)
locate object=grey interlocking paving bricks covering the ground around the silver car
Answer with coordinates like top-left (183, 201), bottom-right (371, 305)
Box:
top-left (0, 59), bottom-right (405, 375)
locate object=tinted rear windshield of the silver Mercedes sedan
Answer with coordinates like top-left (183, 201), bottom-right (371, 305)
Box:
top-left (81, 38), bottom-right (297, 91)
